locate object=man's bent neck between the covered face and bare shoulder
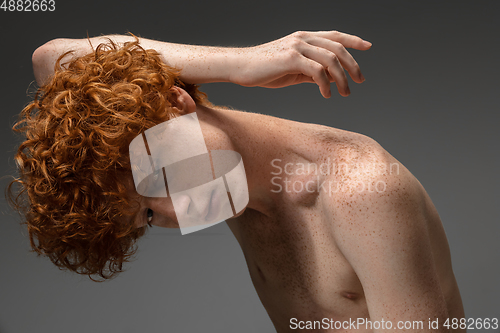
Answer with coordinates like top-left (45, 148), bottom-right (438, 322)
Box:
top-left (196, 106), bottom-right (322, 216)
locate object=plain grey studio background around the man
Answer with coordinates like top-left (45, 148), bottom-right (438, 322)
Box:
top-left (0, 0), bottom-right (500, 333)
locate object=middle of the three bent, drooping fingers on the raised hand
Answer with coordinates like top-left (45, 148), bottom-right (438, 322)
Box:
top-left (303, 46), bottom-right (350, 96)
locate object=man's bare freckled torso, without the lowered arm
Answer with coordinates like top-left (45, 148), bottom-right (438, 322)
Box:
top-left (228, 118), bottom-right (463, 332)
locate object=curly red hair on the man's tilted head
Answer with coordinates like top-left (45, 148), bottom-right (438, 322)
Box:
top-left (7, 38), bottom-right (210, 280)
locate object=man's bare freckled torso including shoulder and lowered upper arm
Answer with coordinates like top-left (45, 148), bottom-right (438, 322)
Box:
top-left (219, 111), bottom-right (464, 332)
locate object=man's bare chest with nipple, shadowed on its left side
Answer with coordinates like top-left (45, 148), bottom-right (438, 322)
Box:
top-left (230, 205), bottom-right (366, 316)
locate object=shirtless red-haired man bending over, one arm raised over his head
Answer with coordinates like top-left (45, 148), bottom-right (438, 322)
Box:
top-left (10, 31), bottom-right (464, 332)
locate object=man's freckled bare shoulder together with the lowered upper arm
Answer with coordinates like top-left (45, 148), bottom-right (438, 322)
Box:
top-left (321, 129), bottom-right (456, 320)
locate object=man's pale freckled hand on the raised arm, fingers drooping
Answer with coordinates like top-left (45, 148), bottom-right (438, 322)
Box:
top-left (230, 31), bottom-right (372, 98)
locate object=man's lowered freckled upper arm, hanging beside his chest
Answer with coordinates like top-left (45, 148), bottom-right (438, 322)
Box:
top-left (331, 150), bottom-right (448, 332)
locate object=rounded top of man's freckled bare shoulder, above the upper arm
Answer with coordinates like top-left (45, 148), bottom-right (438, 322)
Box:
top-left (317, 126), bottom-right (426, 220)
